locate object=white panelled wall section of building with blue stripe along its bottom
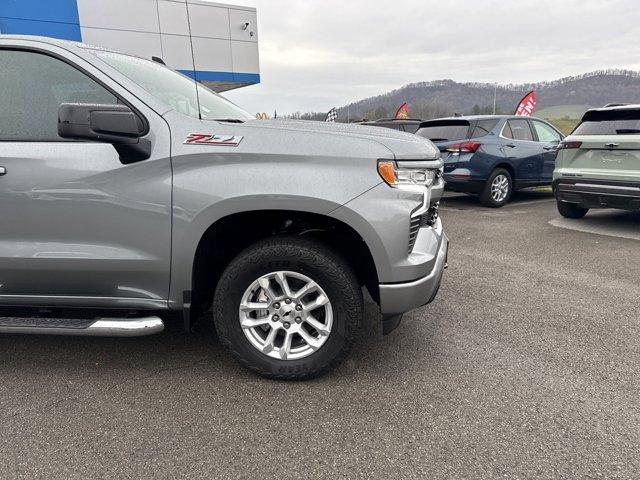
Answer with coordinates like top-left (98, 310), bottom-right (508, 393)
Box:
top-left (77, 0), bottom-right (260, 88)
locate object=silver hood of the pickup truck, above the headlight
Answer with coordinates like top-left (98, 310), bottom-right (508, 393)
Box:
top-left (243, 119), bottom-right (440, 160)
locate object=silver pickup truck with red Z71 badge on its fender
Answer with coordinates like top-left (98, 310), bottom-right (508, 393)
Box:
top-left (0, 36), bottom-right (448, 379)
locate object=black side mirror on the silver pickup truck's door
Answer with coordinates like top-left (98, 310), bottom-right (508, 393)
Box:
top-left (58, 103), bottom-right (151, 163)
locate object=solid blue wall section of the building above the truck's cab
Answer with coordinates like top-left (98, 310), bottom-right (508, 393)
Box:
top-left (0, 0), bottom-right (82, 42)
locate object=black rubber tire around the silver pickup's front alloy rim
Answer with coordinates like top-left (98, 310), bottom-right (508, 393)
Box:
top-left (212, 237), bottom-right (363, 380)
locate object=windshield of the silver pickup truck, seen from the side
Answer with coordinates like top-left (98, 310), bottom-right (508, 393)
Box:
top-left (93, 50), bottom-right (254, 121)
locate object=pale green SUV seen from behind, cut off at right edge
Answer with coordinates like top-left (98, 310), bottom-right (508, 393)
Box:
top-left (553, 105), bottom-right (640, 218)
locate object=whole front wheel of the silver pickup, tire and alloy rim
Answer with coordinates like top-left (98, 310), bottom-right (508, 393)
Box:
top-left (213, 237), bottom-right (363, 379)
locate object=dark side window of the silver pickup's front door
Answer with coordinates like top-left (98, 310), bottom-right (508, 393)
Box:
top-left (0, 50), bottom-right (118, 142)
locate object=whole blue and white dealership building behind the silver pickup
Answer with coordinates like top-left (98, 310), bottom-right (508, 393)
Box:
top-left (0, 0), bottom-right (260, 92)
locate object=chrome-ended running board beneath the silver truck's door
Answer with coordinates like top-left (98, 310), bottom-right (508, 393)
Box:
top-left (0, 316), bottom-right (164, 337)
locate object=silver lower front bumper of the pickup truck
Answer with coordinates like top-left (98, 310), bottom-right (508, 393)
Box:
top-left (380, 232), bottom-right (449, 316)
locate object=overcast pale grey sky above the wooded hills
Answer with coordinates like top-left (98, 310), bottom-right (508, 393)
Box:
top-left (226, 0), bottom-right (640, 115)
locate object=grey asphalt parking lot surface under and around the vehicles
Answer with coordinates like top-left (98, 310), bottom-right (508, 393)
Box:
top-left (0, 193), bottom-right (640, 479)
